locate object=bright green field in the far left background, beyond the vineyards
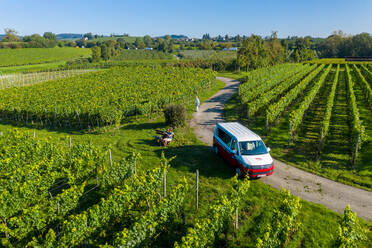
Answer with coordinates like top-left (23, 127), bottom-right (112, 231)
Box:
top-left (0, 47), bottom-right (91, 67)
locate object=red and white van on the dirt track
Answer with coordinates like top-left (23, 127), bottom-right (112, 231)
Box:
top-left (213, 122), bottom-right (274, 178)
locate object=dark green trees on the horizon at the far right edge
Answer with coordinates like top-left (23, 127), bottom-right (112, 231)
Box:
top-left (317, 30), bottom-right (372, 58)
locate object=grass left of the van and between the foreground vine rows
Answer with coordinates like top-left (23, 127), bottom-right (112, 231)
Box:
top-left (0, 75), bottom-right (372, 247)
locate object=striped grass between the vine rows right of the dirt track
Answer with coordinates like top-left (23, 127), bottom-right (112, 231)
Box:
top-left (219, 68), bottom-right (372, 190)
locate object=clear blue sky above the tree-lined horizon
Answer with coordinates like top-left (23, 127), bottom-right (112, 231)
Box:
top-left (0, 0), bottom-right (372, 38)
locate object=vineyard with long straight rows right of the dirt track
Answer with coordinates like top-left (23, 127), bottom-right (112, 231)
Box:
top-left (224, 62), bottom-right (372, 190)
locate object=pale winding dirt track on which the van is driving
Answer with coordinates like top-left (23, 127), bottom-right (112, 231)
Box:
top-left (191, 77), bottom-right (372, 221)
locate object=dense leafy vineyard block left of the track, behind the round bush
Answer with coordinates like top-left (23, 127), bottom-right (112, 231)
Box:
top-left (0, 66), bottom-right (215, 129)
